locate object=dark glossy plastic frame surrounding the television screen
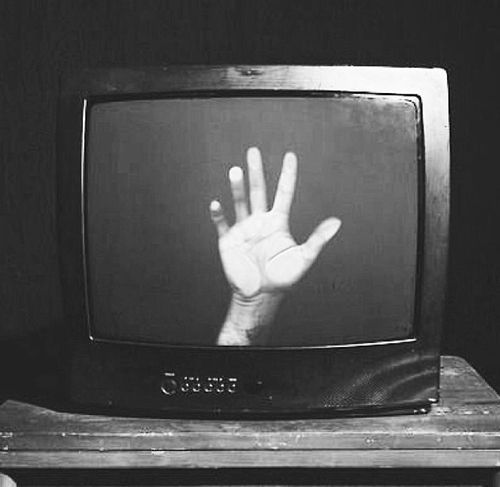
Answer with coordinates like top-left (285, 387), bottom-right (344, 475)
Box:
top-left (57, 66), bottom-right (449, 417)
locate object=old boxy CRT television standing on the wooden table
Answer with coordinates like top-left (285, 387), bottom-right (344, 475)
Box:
top-left (58, 66), bottom-right (449, 417)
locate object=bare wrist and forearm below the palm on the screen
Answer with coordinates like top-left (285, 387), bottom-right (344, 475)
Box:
top-left (217, 292), bottom-right (284, 346)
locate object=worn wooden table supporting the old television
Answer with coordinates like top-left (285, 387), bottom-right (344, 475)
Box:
top-left (0, 356), bottom-right (500, 485)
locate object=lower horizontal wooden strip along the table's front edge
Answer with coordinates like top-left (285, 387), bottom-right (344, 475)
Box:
top-left (0, 450), bottom-right (500, 469)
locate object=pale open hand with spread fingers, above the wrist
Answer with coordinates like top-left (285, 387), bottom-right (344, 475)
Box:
top-left (210, 148), bottom-right (340, 299)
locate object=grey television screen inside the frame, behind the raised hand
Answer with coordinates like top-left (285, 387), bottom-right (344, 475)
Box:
top-left (84, 93), bottom-right (423, 348)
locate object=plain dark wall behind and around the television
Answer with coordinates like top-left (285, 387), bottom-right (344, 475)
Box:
top-left (0, 0), bottom-right (500, 400)
